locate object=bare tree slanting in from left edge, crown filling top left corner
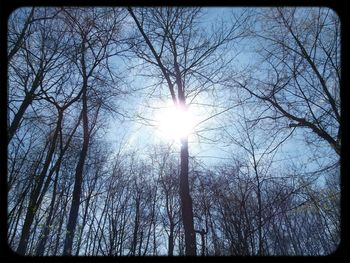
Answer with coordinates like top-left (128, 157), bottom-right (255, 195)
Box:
top-left (8, 8), bottom-right (67, 143)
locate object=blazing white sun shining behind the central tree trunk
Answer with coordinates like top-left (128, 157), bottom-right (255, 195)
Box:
top-left (157, 105), bottom-right (195, 140)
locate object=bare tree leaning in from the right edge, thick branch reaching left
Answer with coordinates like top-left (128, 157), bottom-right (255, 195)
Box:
top-left (233, 8), bottom-right (341, 155)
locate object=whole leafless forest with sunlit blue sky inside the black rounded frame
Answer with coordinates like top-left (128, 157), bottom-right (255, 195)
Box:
top-left (6, 6), bottom-right (342, 256)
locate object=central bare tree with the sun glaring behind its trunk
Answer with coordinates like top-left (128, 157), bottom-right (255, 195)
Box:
top-left (128, 8), bottom-right (244, 255)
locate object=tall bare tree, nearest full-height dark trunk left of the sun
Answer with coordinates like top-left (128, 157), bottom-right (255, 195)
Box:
top-left (51, 8), bottom-right (126, 255)
